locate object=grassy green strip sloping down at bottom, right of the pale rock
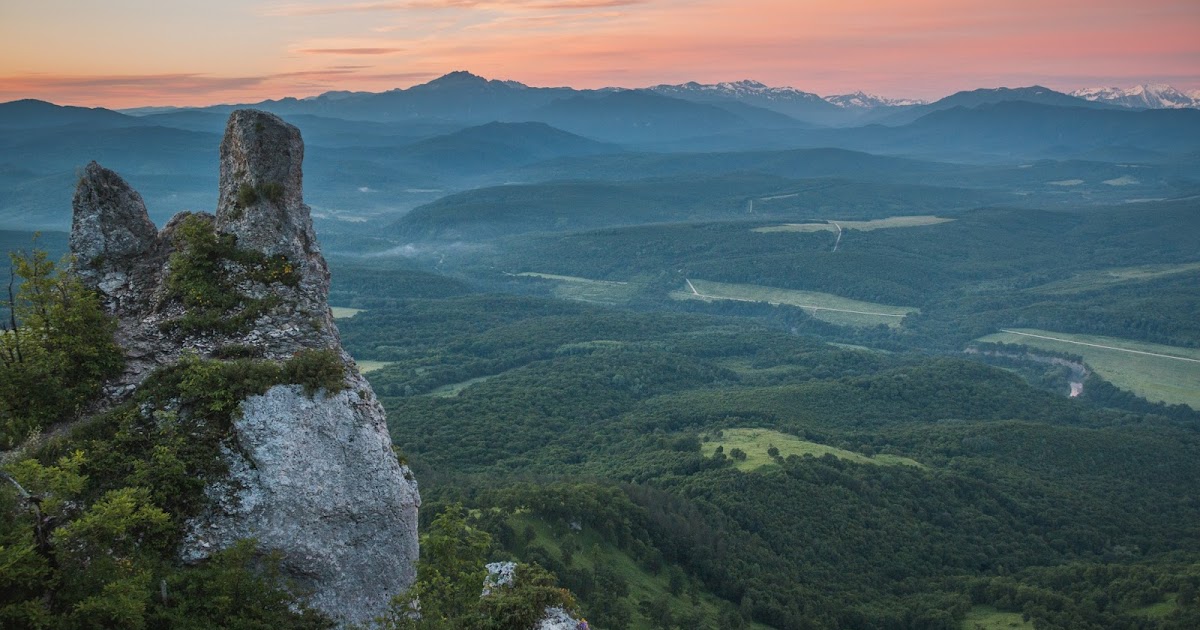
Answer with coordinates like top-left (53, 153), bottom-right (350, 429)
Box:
top-left (509, 512), bottom-right (770, 630)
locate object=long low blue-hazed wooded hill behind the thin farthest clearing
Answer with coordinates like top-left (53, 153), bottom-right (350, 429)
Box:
top-left (392, 173), bottom-right (1002, 241)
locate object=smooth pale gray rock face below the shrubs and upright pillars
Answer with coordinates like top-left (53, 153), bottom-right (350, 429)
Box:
top-left (184, 377), bottom-right (420, 623)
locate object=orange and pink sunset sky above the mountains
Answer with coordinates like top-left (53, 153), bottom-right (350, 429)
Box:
top-left (0, 0), bottom-right (1200, 108)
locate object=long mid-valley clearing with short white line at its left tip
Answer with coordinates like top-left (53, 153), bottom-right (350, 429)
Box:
top-left (671, 278), bottom-right (917, 328)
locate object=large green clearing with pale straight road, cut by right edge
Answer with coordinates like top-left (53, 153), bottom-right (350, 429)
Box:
top-left (977, 329), bottom-right (1200, 409)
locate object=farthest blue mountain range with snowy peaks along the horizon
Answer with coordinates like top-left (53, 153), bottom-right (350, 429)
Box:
top-left (96, 71), bottom-right (1200, 130)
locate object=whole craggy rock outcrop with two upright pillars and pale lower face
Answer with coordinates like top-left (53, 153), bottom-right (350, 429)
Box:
top-left (71, 110), bottom-right (420, 624)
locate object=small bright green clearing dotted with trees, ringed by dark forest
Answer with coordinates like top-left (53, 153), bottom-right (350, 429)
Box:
top-left (701, 428), bottom-right (924, 472)
